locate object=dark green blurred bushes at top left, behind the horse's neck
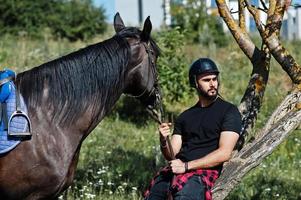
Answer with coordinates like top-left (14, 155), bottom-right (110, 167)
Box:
top-left (0, 0), bottom-right (106, 40)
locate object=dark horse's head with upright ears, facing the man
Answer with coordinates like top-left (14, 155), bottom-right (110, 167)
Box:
top-left (114, 13), bottom-right (161, 107)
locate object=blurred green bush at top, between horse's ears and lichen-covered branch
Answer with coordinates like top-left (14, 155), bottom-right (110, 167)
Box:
top-left (171, 0), bottom-right (227, 46)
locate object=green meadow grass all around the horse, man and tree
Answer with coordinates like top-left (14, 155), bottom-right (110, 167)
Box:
top-left (0, 35), bottom-right (301, 200)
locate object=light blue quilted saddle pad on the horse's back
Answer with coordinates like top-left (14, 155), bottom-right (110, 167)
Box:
top-left (0, 86), bottom-right (28, 154)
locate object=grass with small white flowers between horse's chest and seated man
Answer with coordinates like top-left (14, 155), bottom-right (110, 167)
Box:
top-left (63, 118), bottom-right (160, 199)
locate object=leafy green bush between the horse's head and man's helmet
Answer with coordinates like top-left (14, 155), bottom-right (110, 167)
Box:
top-left (152, 27), bottom-right (191, 104)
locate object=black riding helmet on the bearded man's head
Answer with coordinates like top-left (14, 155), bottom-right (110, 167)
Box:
top-left (189, 58), bottom-right (219, 87)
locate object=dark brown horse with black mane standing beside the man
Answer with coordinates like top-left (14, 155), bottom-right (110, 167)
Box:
top-left (0, 13), bottom-right (161, 200)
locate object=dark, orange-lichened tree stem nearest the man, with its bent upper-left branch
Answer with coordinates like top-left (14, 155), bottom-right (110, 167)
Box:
top-left (216, 0), bottom-right (271, 149)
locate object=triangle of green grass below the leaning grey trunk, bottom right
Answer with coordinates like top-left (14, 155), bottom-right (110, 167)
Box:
top-left (227, 130), bottom-right (301, 200)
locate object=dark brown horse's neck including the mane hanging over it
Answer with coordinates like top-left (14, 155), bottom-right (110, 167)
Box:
top-left (17, 37), bottom-right (128, 139)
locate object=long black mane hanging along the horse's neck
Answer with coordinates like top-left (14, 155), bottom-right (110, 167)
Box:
top-left (16, 36), bottom-right (130, 123)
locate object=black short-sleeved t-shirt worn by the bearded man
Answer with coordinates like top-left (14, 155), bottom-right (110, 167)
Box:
top-left (173, 98), bottom-right (241, 169)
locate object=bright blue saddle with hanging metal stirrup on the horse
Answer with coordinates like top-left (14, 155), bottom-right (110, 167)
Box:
top-left (0, 70), bottom-right (32, 137)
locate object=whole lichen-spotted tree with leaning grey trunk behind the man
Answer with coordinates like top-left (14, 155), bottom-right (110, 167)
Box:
top-left (213, 0), bottom-right (301, 199)
